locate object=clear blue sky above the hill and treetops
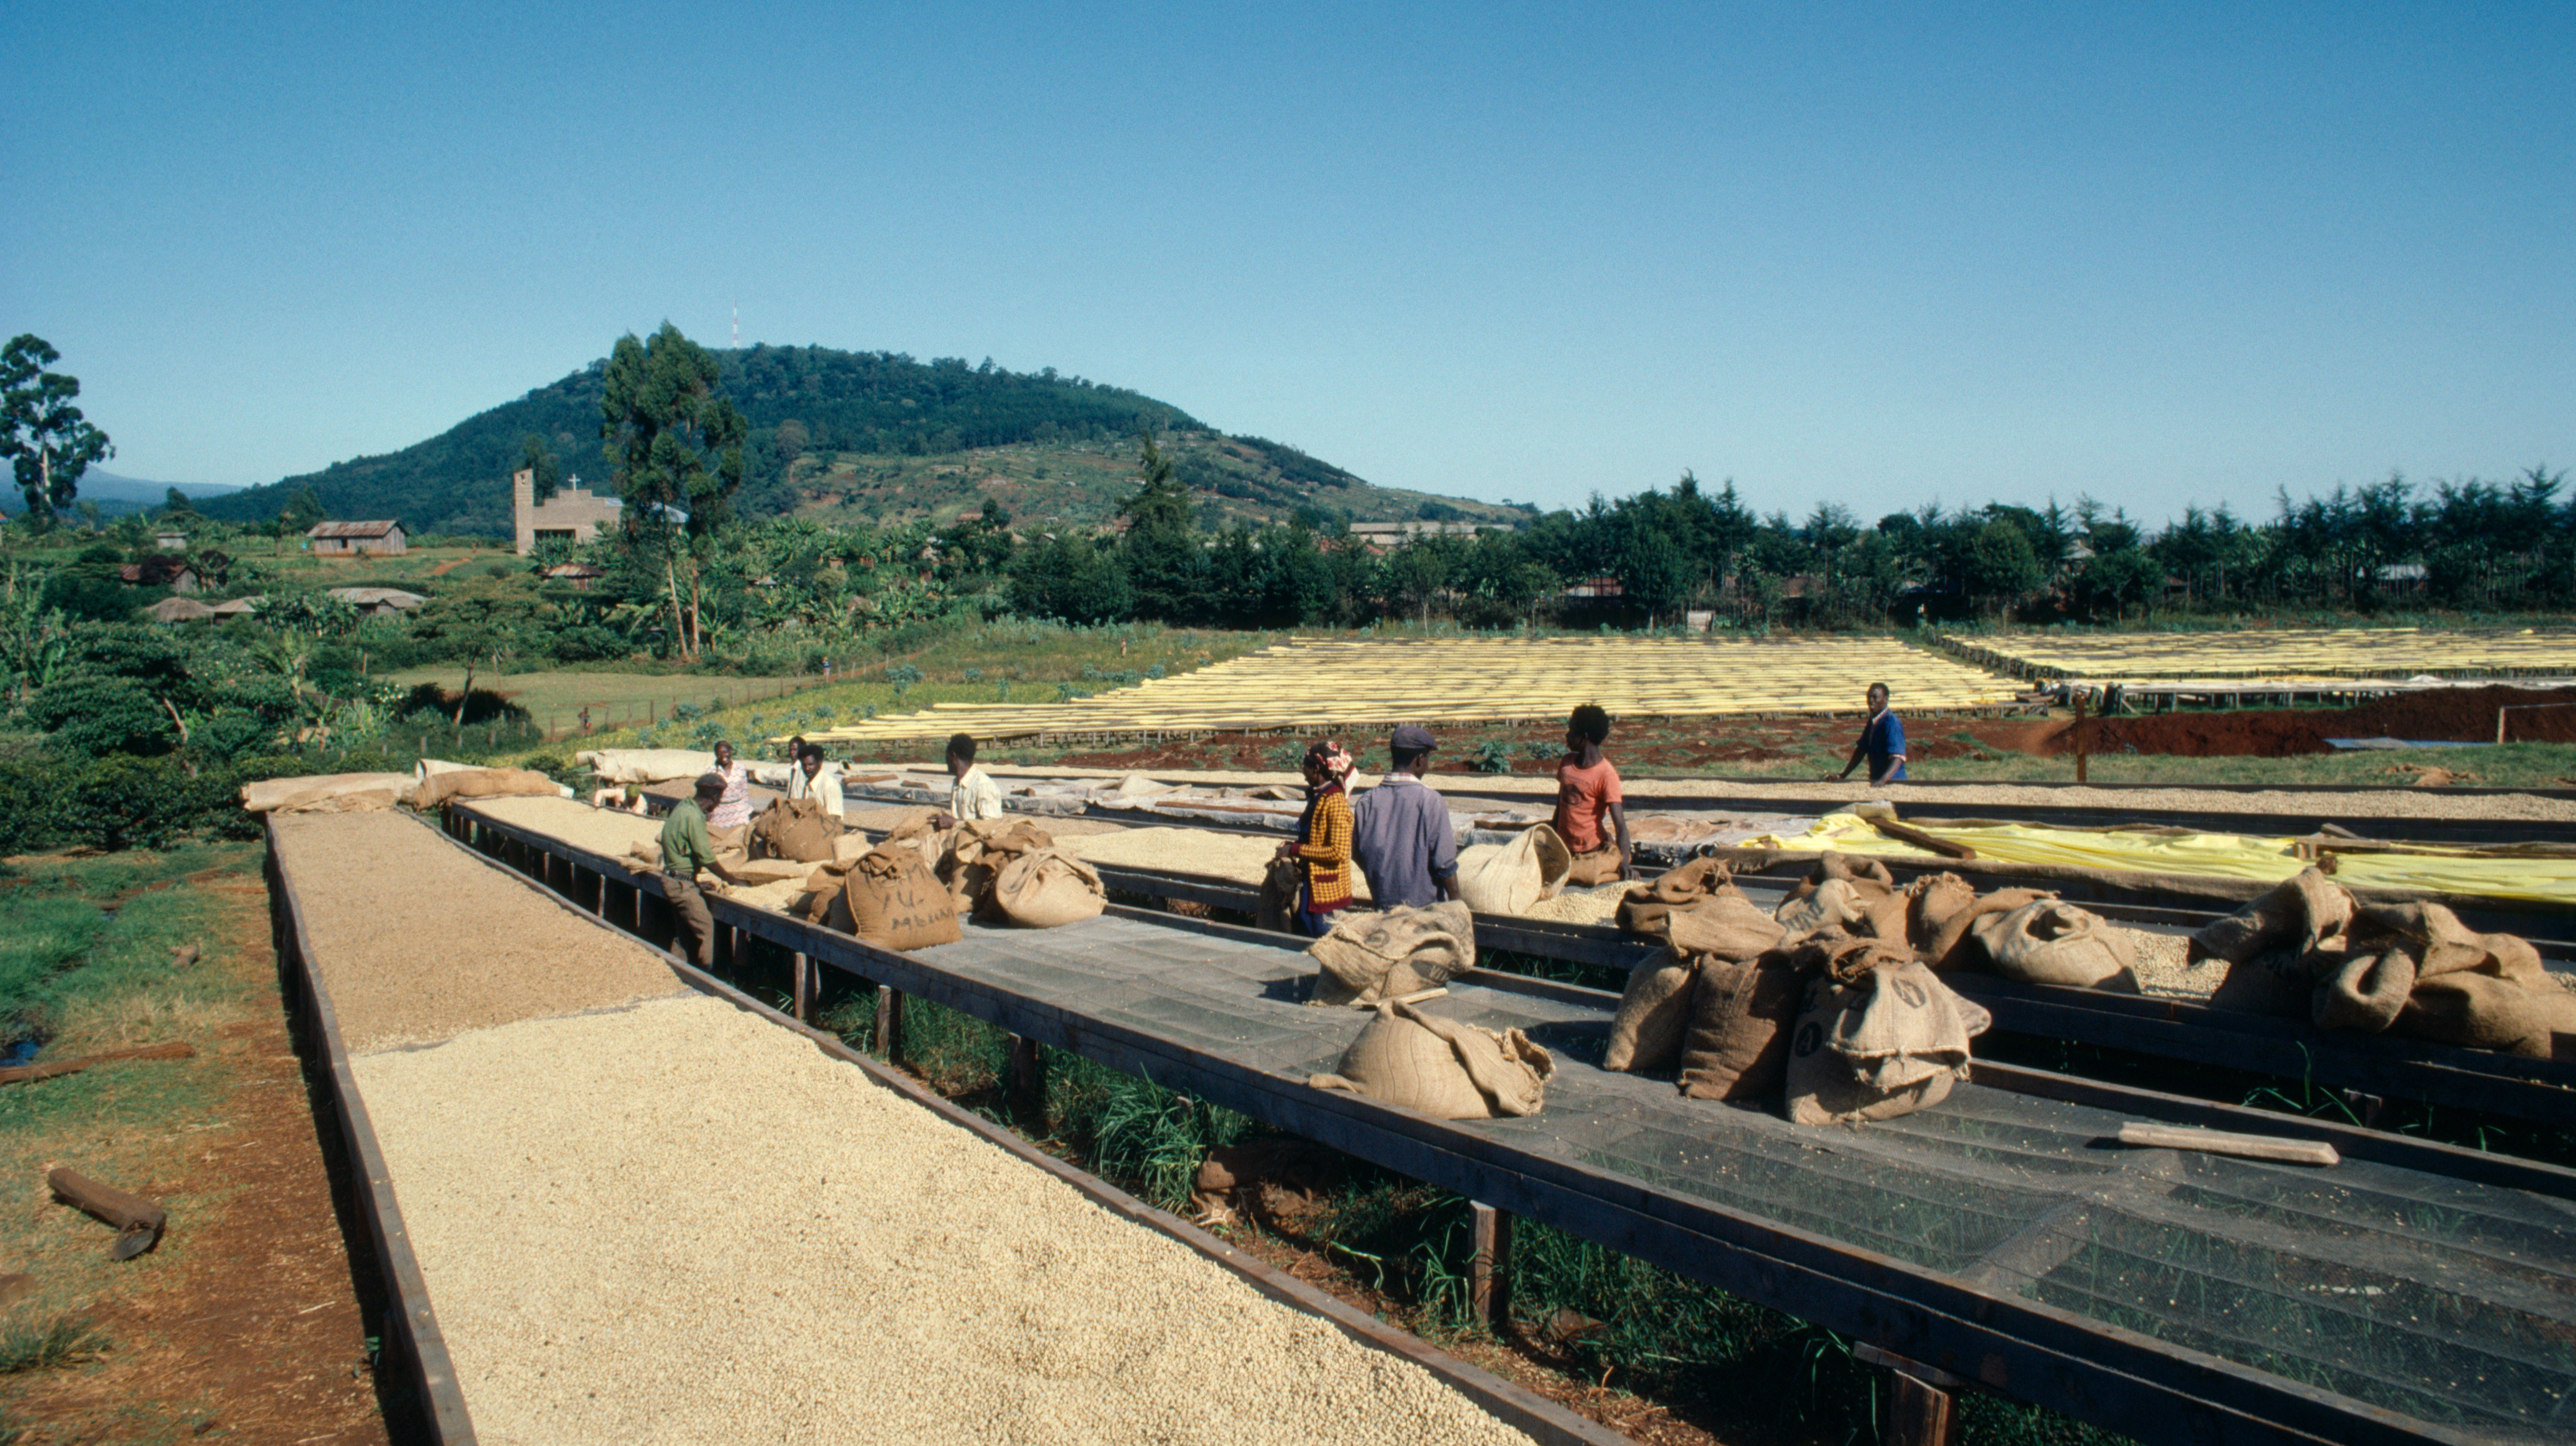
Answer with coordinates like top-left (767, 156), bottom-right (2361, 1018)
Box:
top-left (0, 2), bottom-right (2576, 518)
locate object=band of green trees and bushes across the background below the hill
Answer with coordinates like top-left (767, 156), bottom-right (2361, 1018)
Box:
top-left (0, 325), bottom-right (2576, 848)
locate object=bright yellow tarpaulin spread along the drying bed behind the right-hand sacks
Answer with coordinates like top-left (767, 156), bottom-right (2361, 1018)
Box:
top-left (1739, 812), bottom-right (2576, 905)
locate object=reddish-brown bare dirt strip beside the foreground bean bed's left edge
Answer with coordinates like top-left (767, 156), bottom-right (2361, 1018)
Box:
top-left (5, 874), bottom-right (389, 1446)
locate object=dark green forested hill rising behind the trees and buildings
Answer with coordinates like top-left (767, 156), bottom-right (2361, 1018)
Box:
top-left (198, 345), bottom-right (1512, 536)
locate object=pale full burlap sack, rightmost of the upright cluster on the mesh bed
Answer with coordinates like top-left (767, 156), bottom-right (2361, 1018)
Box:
top-left (1788, 962), bottom-right (1994, 1124)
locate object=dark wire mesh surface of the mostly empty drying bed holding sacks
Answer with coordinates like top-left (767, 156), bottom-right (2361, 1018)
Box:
top-left (917, 917), bottom-right (2576, 1441)
